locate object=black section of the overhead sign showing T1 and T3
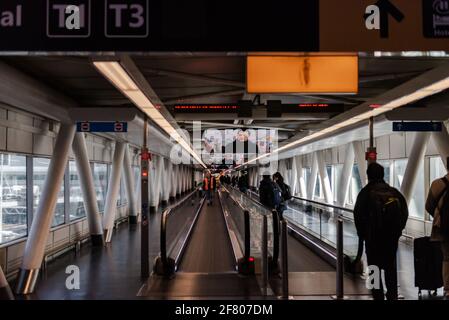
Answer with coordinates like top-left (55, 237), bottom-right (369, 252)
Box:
top-left (0, 0), bottom-right (319, 52)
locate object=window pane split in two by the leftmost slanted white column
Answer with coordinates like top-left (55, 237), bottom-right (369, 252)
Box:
top-left (33, 158), bottom-right (65, 227)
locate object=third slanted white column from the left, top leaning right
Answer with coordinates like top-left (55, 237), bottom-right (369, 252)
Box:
top-left (103, 141), bottom-right (126, 243)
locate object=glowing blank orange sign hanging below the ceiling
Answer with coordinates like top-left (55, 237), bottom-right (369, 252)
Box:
top-left (247, 55), bottom-right (359, 94)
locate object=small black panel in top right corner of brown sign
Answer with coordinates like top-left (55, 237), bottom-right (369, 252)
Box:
top-left (423, 0), bottom-right (449, 38)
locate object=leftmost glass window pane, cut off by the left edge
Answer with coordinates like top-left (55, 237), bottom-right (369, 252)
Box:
top-left (0, 154), bottom-right (27, 243)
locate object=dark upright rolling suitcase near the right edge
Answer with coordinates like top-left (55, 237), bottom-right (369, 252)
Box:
top-left (413, 237), bottom-right (443, 298)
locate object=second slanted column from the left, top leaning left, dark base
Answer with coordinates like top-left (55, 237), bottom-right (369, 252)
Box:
top-left (72, 133), bottom-right (104, 246)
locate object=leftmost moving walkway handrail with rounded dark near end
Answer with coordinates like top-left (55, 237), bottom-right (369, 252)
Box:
top-left (154, 188), bottom-right (205, 276)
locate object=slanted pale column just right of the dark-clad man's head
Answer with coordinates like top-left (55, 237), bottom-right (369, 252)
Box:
top-left (401, 132), bottom-right (430, 204)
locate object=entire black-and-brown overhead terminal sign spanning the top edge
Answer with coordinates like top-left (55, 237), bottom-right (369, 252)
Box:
top-left (0, 0), bottom-right (449, 52)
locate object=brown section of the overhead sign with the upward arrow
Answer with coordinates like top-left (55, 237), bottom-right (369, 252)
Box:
top-left (320, 0), bottom-right (449, 51)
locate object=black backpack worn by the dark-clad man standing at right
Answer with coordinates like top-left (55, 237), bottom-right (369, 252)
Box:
top-left (367, 184), bottom-right (408, 242)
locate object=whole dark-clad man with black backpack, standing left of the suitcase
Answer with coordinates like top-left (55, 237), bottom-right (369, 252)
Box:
top-left (354, 163), bottom-right (408, 300)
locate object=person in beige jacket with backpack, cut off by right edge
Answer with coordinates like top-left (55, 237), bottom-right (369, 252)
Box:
top-left (426, 157), bottom-right (449, 299)
